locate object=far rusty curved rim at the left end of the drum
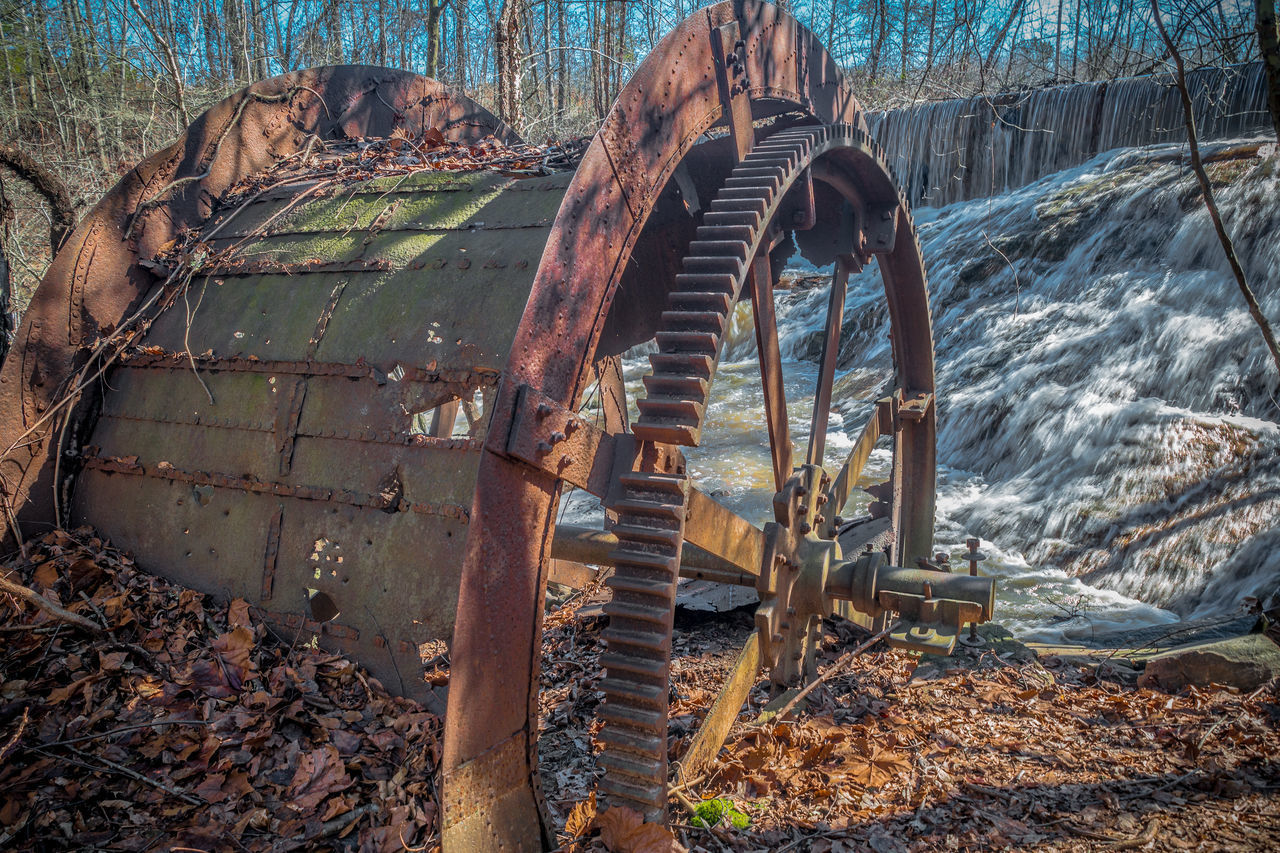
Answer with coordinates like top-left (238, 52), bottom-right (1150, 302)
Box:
top-left (0, 65), bottom-right (520, 542)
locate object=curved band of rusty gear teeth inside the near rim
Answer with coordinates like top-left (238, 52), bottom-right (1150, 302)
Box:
top-left (598, 124), bottom-right (916, 821)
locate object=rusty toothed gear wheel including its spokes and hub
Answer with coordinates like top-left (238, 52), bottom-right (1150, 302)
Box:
top-left (583, 126), bottom-right (936, 821)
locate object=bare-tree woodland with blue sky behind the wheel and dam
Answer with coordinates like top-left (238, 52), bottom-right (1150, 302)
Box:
top-left (0, 0), bottom-right (1257, 322)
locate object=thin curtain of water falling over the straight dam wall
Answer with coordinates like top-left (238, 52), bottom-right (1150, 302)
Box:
top-left (867, 63), bottom-right (1271, 207)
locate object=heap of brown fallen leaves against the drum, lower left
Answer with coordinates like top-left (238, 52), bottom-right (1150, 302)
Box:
top-left (0, 530), bottom-right (440, 852)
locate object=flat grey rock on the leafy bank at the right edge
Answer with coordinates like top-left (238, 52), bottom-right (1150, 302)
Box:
top-left (1138, 634), bottom-right (1280, 690)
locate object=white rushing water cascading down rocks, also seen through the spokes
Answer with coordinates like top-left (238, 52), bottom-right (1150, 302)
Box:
top-left (568, 133), bottom-right (1280, 642)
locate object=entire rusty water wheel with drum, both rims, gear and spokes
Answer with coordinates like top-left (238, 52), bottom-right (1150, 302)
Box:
top-left (0, 1), bottom-right (991, 850)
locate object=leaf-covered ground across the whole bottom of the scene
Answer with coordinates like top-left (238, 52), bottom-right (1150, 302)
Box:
top-left (0, 530), bottom-right (1280, 853)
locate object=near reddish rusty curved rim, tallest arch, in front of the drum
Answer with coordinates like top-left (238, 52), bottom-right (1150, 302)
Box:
top-left (442, 0), bottom-right (932, 849)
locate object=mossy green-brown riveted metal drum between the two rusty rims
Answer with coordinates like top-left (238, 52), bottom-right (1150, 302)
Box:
top-left (72, 170), bottom-right (571, 712)
